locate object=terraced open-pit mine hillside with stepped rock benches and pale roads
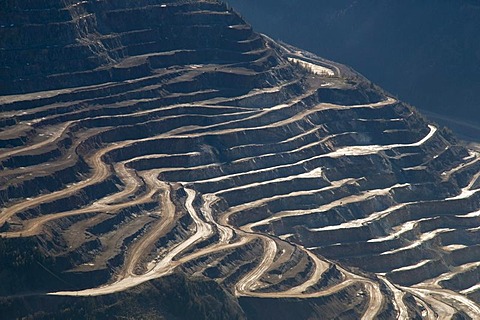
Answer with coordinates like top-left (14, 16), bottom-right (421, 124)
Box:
top-left (0, 0), bottom-right (480, 319)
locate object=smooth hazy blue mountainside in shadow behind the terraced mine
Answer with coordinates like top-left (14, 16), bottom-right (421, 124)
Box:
top-left (228, 0), bottom-right (480, 141)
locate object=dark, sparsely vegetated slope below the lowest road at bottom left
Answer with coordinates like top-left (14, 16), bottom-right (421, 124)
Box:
top-left (0, 274), bottom-right (245, 320)
